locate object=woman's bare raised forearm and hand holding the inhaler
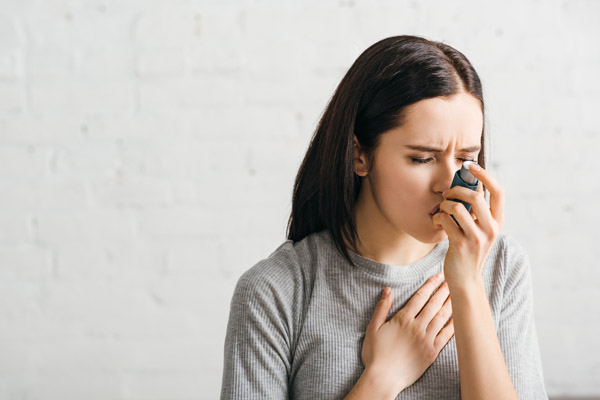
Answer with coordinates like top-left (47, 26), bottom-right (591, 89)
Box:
top-left (434, 165), bottom-right (517, 399)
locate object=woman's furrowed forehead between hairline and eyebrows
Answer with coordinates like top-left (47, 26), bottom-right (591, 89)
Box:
top-left (382, 93), bottom-right (483, 147)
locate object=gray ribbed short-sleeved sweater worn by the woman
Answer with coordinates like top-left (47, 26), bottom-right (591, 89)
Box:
top-left (221, 230), bottom-right (548, 400)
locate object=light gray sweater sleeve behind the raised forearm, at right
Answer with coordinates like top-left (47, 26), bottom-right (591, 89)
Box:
top-left (498, 237), bottom-right (548, 400)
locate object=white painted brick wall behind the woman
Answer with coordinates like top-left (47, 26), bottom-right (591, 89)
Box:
top-left (0, 0), bottom-right (600, 400)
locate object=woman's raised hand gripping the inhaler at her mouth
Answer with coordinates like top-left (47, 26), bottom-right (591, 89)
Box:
top-left (433, 165), bottom-right (504, 288)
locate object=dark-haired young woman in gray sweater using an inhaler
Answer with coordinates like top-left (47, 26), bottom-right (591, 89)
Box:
top-left (221, 36), bottom-right (547, 399)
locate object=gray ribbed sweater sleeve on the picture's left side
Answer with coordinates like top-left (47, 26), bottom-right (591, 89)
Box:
top-left (221, 245), bottom-right (298, 400)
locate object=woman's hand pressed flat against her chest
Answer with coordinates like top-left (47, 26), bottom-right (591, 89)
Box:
top-left (361, 274), bottom-right (454, 397)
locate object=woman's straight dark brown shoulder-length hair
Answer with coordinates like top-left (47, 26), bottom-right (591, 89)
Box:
top-left (287, 35), bottom-right (485, 263)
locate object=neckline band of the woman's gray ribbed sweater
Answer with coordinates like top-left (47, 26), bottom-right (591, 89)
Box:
top-left (319, 230), bottom-right (448, 280)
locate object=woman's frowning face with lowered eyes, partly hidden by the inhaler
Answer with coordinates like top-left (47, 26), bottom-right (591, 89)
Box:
top-left (355, 93), bottom-right (483, 243)
